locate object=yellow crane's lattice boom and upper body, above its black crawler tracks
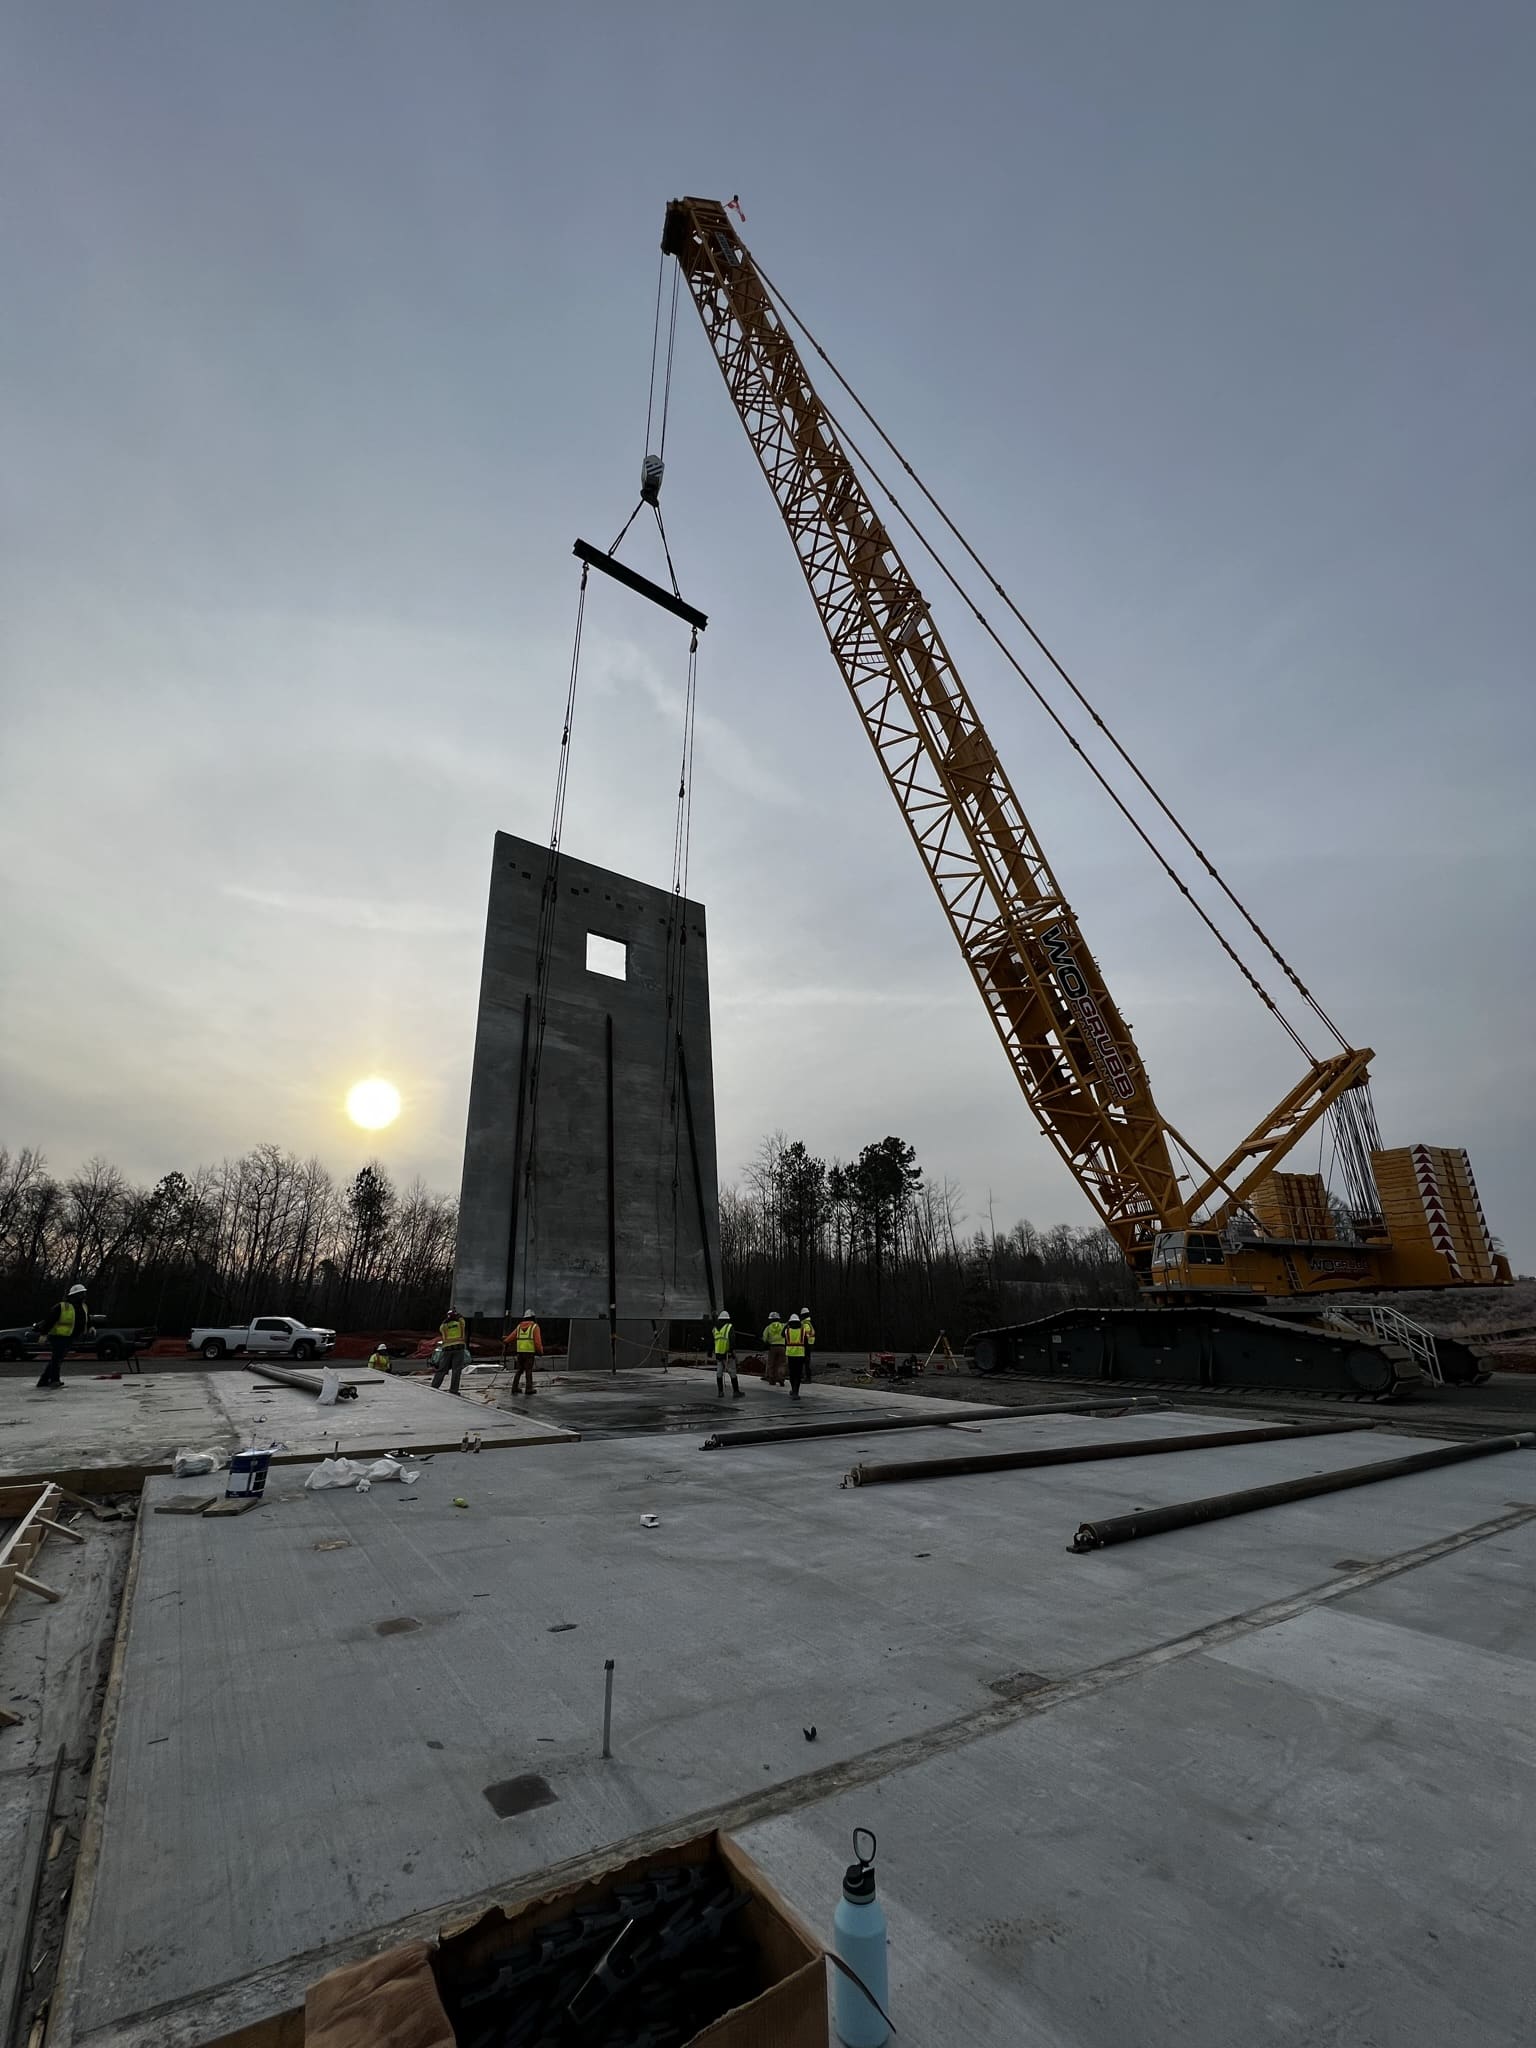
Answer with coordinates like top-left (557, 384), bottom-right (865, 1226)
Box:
top-left (662, 199), bottom-right (1509, 1392)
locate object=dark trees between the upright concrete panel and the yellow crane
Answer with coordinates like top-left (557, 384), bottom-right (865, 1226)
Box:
top-left (721, 1133), bottom-right (1135, 1352)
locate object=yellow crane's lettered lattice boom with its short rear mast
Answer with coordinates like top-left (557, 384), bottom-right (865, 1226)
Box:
top-left (662, 199), bottom-right (1372, 1266)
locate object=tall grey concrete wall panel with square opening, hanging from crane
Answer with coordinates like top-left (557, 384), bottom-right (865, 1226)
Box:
top-left (455, 831), bottom-right (721, 1319)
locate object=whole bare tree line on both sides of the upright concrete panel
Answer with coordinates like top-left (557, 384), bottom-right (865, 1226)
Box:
top-left (0, 1133), bottom-right (1133, 1352)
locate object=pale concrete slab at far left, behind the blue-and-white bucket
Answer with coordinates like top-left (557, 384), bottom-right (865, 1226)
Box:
top-left (0, 1366), bottom-right (569, 1487)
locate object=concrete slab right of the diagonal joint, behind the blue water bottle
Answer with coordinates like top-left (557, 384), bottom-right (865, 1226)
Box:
top-left (741, 1524), bottom-right (1536, 2048)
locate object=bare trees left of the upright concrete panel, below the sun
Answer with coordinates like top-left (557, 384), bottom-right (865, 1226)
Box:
top-left (0, 1145), bottom-right (457, 1335)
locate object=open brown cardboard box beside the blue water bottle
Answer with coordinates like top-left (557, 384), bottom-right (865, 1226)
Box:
top-left (303, 1833), bottom-right (827, 2048)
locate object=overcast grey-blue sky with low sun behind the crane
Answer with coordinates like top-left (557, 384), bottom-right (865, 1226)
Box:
top-left (0, 0), bottom-right (1536, 1266)
